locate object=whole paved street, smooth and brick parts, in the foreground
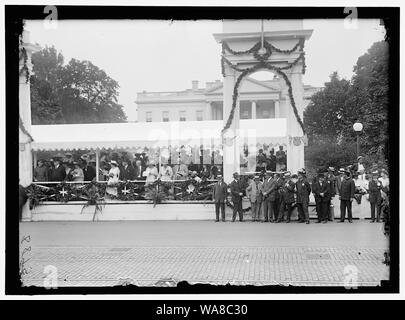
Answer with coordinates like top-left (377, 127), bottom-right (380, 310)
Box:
top-left (20, 220), bottom-right (388, 286)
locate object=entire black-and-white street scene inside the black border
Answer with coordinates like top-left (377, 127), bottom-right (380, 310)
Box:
top-left (8, 6), bottom-right (399, 293)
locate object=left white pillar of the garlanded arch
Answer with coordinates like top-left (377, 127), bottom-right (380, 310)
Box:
top-left (223, 66), bottom-right (240, 183)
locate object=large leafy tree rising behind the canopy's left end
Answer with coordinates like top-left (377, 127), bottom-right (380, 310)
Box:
top-left (32, 47), bottom-right (126, 124)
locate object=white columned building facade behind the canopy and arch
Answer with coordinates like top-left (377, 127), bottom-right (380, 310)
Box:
top-left (135, 77), bottom-right (320, 122)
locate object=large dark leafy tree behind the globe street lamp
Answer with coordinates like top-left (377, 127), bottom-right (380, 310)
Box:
top-left (304, 41), bottom-right (389, 169)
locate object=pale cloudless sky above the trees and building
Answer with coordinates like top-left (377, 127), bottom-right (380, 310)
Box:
top-left (25, 19), bottom-right (385, 121)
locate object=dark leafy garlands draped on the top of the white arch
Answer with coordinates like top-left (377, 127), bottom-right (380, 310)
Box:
top-left (221, 38), bottom-right (306, 135)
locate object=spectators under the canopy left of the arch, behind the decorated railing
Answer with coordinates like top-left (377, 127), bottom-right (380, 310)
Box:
top-left (34, 153), bottom-right (222, 183)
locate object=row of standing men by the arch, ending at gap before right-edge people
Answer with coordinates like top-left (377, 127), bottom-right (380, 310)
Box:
top-left (213, 168), bottom-right (355, 224)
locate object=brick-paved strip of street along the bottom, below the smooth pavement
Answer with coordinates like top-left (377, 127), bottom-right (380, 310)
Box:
top-left (23, 246), bottom-right (389, 287)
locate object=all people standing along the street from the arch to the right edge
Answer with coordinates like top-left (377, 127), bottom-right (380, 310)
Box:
top-left (213, 157), bottom-right (389, 224)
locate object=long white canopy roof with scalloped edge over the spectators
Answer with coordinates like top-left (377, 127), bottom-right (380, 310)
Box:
top-left (31, 118), bottom-right (287, 150)
